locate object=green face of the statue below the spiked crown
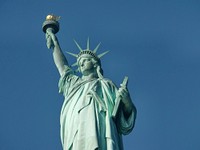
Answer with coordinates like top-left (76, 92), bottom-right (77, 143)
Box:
top-left (79, 55), bottom-right (95, 76)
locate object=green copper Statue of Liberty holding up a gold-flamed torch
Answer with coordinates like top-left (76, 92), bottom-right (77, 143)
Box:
top-left (43, 16), bottom-right (136, 150)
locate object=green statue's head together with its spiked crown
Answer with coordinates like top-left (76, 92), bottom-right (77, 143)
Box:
top-left (67, 39), bottom-right (108, 77)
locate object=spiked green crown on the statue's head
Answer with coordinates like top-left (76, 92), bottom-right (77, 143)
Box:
top-left (67, 38), bottom-right (109, 66)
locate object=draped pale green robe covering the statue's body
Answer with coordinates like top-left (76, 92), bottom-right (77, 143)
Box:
top-left (59, 66), bottom-right (136, 150)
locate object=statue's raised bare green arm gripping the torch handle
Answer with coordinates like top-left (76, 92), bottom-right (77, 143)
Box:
top-left (46, 28), bottom-right (68, 76)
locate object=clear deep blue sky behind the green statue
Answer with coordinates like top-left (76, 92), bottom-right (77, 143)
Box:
top-left (0, 0), bottom-right (200, 150)
